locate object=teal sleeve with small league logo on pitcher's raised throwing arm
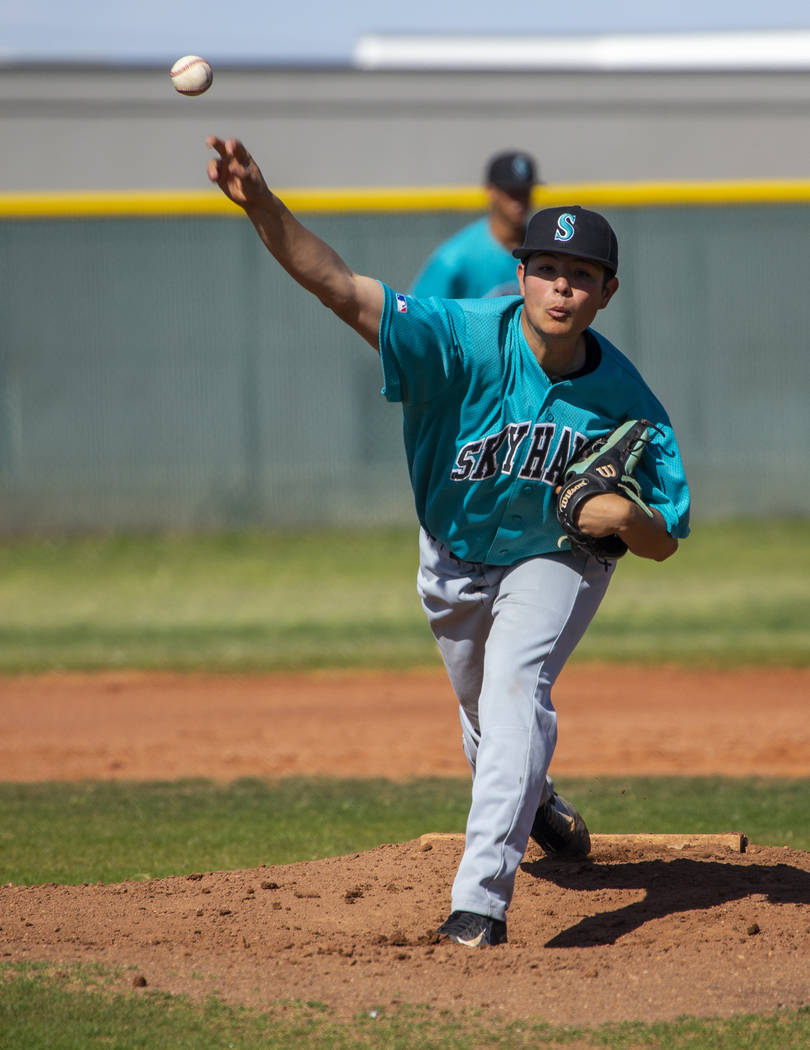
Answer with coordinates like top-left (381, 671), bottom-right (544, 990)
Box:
top-left (379, 285), bottom-right (463, 404)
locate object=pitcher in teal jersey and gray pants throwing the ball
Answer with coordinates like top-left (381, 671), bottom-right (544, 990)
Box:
top-left (208, 138), bottom-right (689, 946)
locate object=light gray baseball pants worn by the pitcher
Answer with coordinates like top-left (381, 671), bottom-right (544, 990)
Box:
top-left (417, 529), bottom-right (615, 919)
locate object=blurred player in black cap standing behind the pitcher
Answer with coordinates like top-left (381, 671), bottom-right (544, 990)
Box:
top-left (411, 150), bottom-right (538, 299)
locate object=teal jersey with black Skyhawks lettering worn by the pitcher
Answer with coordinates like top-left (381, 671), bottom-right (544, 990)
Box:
top-left (379, 285), bottom-right (689, 565)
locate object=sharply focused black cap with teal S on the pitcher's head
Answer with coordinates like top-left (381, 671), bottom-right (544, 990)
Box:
top-left (512, 205), bottom-right (619, 273)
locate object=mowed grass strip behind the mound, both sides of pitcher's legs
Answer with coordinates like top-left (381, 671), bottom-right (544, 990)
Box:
top-left (0, 777), bottom-right (810, 885)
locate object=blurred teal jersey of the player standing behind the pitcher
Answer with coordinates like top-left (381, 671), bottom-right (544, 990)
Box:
top-left (411, 217), bottom-right (519, 299)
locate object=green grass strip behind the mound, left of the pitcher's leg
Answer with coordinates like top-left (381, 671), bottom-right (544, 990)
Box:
top-left (0, 777), bottom-right (470, 885)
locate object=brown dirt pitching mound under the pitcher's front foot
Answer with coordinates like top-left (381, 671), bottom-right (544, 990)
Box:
top-left (0, 840), bottom-right (810, 1025)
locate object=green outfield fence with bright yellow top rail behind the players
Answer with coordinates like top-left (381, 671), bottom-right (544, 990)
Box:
top-left (0, 182), bottom-right (810, 536)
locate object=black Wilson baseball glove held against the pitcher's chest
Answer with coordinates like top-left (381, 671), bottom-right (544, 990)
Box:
top-left (557, 419), bottom-right (658, 562)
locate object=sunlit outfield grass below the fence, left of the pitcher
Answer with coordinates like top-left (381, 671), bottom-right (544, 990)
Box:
top-left (0, 530), bottom-right (436, 673)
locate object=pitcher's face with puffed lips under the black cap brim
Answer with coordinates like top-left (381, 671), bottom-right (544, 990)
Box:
top-left (518, 252), bottom-right (619, 340)
